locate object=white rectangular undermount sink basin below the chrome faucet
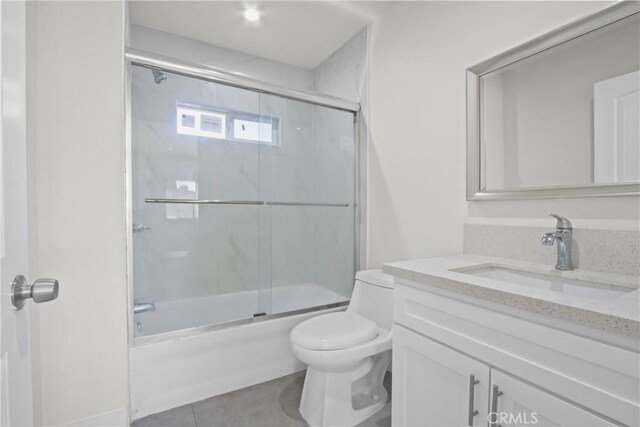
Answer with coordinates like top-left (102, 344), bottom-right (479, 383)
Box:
top-left (454, 265), bottom-right (635, 300)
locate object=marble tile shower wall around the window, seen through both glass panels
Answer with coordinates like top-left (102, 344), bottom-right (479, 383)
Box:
top-left (132, 61), bottom-right (354, 301)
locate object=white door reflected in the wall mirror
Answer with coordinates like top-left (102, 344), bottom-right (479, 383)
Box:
top-left (593, 71), bottom-right (640, 183)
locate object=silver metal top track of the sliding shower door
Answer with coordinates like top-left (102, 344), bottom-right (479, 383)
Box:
top-left (125, 48), bottom-right (360, 114)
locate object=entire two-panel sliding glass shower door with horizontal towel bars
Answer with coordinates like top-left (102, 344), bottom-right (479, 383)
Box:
top-left (129, 66), bottom-right (355, 336)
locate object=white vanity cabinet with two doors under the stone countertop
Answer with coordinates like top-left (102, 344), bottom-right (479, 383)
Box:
top-left (392, 282), bottom-right (640, 427)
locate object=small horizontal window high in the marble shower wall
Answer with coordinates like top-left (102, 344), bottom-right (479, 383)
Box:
top-left (176, 103), bottom-right (280, 146)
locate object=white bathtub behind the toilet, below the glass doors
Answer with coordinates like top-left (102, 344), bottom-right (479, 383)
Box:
top-left (129, 284), bottom-right (347, 420)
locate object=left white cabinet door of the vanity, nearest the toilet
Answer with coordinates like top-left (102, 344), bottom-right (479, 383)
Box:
top-left (392, 325), bottom-right (490, 427)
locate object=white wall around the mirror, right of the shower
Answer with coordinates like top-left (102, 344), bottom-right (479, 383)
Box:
top-left (369, 2), bottom-right (639, 268)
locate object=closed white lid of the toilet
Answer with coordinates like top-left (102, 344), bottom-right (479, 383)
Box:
top-left (291, 311), bottom-right (378, 350)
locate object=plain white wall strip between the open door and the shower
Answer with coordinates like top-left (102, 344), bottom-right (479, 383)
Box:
top-left (27, 1), bottom-right (128, 426)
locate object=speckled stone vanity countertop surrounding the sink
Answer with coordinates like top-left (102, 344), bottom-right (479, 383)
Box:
top-left (382, 254), bottom-right (640, 337)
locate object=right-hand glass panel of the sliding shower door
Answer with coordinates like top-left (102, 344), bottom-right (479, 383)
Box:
top-left (260, 94), bottom-right (355, 314)
